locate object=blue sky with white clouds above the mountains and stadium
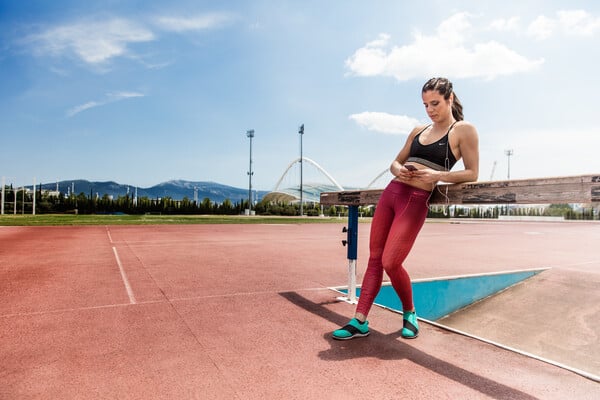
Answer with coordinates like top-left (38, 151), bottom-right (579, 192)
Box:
top-left (0, 0), bottom-right (600, 190)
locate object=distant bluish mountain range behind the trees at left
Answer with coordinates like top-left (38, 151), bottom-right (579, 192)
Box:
top-left (42, 179), bottom-right (269, 203)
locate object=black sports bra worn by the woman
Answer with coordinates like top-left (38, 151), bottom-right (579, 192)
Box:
top-left (406, 121), bottom-right (456, 171)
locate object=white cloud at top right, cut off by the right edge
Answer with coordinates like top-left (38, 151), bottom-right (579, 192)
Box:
top-left (527, 10), bottom-right (600, 40)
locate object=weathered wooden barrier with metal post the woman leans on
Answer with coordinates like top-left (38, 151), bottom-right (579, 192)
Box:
top-left (321, 174), bottom-right (600, 303)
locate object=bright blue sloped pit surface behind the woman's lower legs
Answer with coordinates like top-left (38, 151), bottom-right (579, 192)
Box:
top-left (343, 269), bottom-right (544, 321)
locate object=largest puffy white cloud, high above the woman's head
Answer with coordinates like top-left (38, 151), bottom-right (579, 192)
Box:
top-left (346, 13), bottom-right (544, 81)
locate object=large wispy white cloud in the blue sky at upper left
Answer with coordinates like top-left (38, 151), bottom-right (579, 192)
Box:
top-left (28, 18), bottom-right (155, 64)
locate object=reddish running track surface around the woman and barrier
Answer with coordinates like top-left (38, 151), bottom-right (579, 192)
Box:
top-left (0, 220), bottom-right (600, 399)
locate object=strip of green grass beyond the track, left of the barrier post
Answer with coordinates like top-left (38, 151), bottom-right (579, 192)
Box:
top-left (0, 214), bottom-right (347, 226)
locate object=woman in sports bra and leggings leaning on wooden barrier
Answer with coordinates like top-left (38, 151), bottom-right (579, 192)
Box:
top-left (333, 78), bottom-right (479, 340)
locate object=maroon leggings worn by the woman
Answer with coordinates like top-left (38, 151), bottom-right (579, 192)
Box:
top-left (356, 180), bottom-right (430, 316)
